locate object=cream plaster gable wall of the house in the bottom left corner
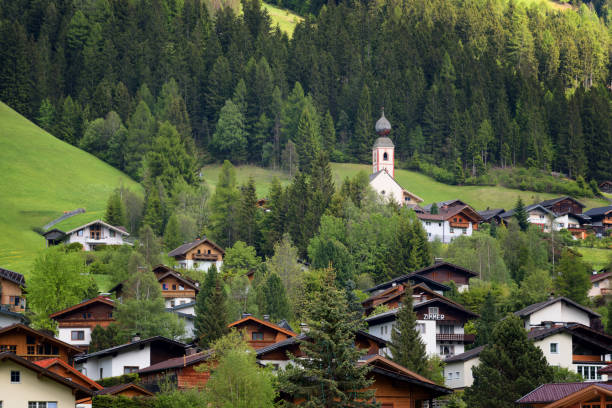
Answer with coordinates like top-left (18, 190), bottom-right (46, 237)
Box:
top-left (0, 361), bottom-right (76, 408)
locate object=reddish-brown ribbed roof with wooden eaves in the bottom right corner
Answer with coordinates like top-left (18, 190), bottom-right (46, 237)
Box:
top-left (516, 382), bottom-right (612, 408)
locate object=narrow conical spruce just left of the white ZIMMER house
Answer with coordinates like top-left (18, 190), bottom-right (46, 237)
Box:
top-left (389, 288), bottom-right (427, 374)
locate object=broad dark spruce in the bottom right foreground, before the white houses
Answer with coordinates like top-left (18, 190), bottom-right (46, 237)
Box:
top-left (465, 314), bottom-right (553, 408)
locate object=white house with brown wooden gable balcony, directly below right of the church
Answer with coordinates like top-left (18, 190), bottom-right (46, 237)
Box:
top-left (414, 200), bottom-right (482, 244)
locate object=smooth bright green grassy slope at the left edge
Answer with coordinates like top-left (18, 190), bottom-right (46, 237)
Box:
top-left (0, 103), bottom-right (141, 274)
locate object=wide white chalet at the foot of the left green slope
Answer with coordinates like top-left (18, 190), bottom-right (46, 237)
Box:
top-left (43, 220), bottom-right (131, 251)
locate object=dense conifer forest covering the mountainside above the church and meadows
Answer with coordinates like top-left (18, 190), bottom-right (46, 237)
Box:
top-left (0, 0), bottom-right (612, 185)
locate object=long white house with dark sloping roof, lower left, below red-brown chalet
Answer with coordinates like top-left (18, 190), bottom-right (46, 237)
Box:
top-left (74, 336), bottom-right (187, 381)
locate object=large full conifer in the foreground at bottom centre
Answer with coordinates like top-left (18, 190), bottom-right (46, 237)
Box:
top-left (279, 270), bottom-right (378, 408)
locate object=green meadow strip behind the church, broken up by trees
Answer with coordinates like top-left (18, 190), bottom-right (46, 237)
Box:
top-left (202, 163), bottom-right (609, 210)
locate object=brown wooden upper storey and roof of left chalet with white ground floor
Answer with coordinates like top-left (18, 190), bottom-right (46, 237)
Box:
top-left (49, 296), bottom-right (115, 330)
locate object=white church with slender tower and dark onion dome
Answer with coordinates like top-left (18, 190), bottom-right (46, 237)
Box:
top-left (370, 109), bottom-right (423, 208)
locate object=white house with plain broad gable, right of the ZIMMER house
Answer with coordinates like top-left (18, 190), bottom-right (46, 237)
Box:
top-left (514, 296), bottom-right (601, 330)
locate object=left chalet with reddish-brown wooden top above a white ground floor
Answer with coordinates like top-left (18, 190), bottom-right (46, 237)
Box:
top-left (49, 296), bottom-right (115, 352)
